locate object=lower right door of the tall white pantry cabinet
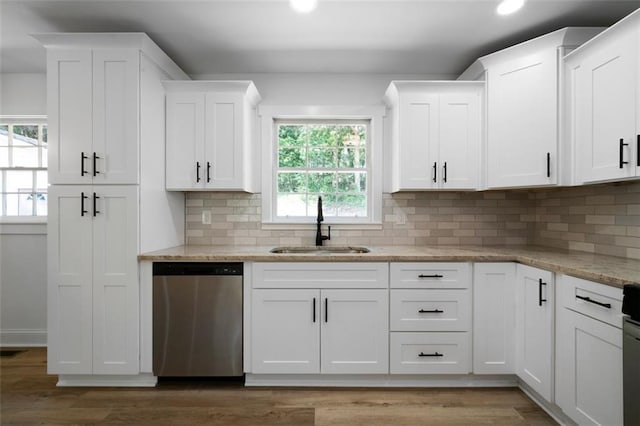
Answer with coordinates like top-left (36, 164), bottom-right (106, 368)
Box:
top-left (91, 185), bottom-right (139, 374)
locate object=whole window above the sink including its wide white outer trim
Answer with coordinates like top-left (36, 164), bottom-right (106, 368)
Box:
top-left (259, 106), bottom-right (384, 226)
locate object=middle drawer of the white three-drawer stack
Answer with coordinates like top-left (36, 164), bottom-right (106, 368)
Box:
top-left (389, 289), bottom-right (471, 331)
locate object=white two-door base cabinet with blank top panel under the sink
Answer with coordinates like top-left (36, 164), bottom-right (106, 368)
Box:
top-left (251, 263), bottom-right (389, 374)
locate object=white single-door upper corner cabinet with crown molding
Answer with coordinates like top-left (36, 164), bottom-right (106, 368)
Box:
top-left (460, 28), bottom-right (601, 188)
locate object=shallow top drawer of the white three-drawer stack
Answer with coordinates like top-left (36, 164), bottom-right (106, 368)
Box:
top-left (389, 262), bottom-right (471, 288)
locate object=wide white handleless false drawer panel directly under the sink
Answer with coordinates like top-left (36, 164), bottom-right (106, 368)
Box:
top-left (252, 262), bottom-right (389, 289)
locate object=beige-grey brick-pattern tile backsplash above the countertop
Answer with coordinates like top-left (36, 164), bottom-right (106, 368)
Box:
top-left (186, 182), bottom-right (640, 259)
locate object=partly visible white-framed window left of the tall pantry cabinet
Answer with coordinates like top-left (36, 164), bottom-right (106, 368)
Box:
top-left (0, 118), bottom-right (47, 216)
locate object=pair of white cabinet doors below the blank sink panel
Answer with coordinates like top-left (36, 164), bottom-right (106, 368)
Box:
top-left (251, 269), bottom-right (389, 374)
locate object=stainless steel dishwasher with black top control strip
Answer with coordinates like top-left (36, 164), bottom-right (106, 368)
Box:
top-left (153, 262), bottom-right (243, 377)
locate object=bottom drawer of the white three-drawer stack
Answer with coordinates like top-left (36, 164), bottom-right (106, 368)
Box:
top-left (390, 333), bottom-right (471, 374)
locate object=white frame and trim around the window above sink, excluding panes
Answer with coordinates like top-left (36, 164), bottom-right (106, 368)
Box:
top-left (258, 105), bottom-right (385, 227)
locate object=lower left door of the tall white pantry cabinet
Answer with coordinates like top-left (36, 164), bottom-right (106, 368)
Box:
top-left (47, 185), bottom-right (93, 374)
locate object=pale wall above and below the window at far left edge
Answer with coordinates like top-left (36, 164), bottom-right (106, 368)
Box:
top-left (0, 74), bottom-right (47, 347)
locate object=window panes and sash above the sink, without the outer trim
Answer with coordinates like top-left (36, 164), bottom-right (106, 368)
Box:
top-left (275, 120), bottom-right (370, 220)
